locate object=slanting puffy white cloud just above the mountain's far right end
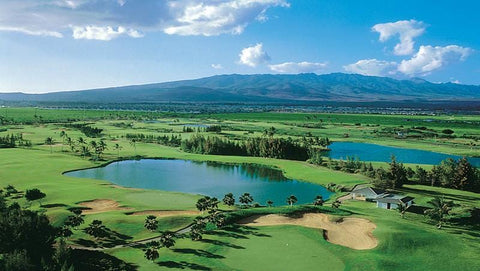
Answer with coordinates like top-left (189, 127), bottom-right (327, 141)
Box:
top-left (398, 45), bottom-right (473, 76)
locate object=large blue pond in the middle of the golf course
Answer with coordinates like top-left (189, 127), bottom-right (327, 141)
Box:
top-left (65, 159), bottom-right (332, 206)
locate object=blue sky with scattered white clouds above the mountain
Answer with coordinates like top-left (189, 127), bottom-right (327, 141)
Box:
top-left (0, 0), bottom-right (480, 93)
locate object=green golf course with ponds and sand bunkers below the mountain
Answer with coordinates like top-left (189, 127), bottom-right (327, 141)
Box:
top-left (0, 107), bottom-right (480, 270)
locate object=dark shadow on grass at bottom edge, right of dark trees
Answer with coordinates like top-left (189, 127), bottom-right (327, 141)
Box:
top-left (71, 249), bottom-right (138, 271)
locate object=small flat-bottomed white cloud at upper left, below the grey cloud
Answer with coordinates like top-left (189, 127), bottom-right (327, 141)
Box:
top-left (72, 25), bottom-right (143, 40)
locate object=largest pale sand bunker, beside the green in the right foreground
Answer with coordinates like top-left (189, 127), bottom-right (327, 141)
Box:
top-left (237, 213), bottom-right (378, 249)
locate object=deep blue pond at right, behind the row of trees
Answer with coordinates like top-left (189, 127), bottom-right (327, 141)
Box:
top-left (326, 142), bottom-right (480, 167)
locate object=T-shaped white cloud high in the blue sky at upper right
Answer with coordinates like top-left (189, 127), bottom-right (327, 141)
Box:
top-left (372, 20), bottom-right (425, 55)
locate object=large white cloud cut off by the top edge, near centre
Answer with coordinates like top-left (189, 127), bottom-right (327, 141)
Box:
top-left (164, 0), bottom-right (289, 36)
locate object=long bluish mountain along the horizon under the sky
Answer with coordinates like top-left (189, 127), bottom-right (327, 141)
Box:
top-left (0, 73), bottom-right (480, 103)
